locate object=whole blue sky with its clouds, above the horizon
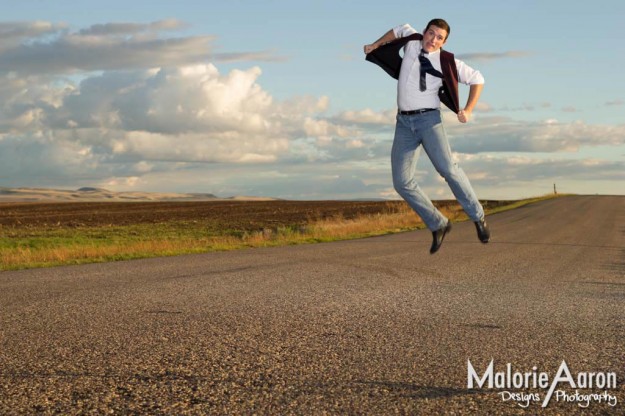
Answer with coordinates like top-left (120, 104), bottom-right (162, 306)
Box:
top-left (0, 0), bottom-right (625, 199)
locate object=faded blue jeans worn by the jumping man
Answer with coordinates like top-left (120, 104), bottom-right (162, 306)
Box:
top-left (391, 110), bottom-right (484, 231)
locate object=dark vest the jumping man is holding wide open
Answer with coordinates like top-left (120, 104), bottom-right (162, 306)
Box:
top-left (365, 33), bottom-right (460, 114)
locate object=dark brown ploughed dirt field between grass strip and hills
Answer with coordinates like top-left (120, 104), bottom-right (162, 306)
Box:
top-left (0, 201), bottom-right (502, 230)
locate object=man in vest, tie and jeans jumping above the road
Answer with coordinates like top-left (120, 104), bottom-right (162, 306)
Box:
top-left (364, 19), bottom-right (490, 254)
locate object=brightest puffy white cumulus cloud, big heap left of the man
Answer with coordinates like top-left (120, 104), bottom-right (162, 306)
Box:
top-left (55, 64), bottom-right (272, 134)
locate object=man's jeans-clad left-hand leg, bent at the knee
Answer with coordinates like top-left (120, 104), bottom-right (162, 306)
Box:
top-left (391, 115), bottom-right (447, 231)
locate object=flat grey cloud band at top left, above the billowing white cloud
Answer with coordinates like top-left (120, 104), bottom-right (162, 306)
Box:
top-left (0, 19), bottom-right (285, 74)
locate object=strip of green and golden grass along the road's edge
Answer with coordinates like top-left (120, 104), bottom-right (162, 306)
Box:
top-left (0, 195), bottom-right (555, 270)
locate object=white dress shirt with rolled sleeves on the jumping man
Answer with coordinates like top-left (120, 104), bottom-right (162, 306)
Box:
top-left (393, 24), bottom-right (484, 111)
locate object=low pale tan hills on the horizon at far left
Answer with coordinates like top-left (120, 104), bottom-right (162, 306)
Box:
top-left (0, 187), bottom-right (274, 202)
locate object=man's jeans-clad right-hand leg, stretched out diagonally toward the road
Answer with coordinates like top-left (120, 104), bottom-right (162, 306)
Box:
top-left (421, 111), bottom-right (484, 222)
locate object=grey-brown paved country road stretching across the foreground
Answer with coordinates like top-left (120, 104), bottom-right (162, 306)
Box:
top-left (0, 196), bottom-right (625, 415)
